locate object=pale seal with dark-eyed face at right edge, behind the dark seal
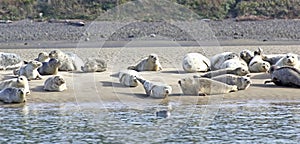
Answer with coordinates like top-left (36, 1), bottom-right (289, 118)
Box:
top-left (275, 53), bottom-right (300, 69)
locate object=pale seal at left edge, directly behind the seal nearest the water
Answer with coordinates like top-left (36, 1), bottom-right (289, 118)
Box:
top-left (0, 76), bottom-right (30, 95)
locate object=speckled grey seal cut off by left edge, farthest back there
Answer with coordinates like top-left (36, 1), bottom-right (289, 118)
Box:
top-left (0, 52), bottom-right (23, 70)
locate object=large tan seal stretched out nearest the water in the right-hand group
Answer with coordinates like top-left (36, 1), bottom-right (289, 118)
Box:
top-left (178, 77), bottom-right (238, 96)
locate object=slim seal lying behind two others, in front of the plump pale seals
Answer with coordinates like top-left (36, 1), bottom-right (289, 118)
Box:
top-left (194, 67), bottom-right (250, 78)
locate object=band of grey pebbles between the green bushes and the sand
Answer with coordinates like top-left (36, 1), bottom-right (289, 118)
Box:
top-left (0, 19), bottom-right (300, 43)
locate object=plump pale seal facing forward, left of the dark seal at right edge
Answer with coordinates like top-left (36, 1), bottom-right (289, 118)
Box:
top-left (249, 52), bottom-right (271, 73)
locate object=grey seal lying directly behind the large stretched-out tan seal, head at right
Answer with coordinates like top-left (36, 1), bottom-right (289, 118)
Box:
top-left (211, 74), bottom-right (252, 90)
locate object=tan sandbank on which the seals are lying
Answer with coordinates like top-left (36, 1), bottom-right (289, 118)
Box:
top-left (0, 45), bottom-right (300, 106)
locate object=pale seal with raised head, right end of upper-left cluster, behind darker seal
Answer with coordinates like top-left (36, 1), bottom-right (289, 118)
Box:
top-left (49, 50), bottom-right (76, 71)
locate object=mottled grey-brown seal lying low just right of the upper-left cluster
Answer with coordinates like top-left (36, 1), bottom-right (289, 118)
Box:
top-left (81, 58), bottom-right (107, 72)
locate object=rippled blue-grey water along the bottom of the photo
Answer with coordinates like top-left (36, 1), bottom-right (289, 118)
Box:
top-left (0, 102), bottom-right (300, 143)
